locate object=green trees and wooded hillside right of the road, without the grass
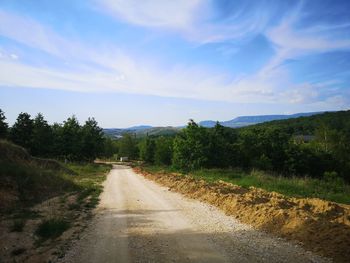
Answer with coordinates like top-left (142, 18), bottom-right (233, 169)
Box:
top-left (134, 111), bottom-right (350, 181)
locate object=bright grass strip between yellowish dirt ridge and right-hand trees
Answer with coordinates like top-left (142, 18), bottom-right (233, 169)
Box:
top-left (143, 165), bottom-right (350, 204)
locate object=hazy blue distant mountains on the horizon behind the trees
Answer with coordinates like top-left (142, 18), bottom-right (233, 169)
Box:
top-left (103, 112), bottom-right (324, 138)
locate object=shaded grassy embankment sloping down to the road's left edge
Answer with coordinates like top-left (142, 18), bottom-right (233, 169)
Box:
top-left (0, 141), bottom-right (111, 260)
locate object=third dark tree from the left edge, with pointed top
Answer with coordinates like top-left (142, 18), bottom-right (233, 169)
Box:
top-left (31, 113), bottom-right (53, 156)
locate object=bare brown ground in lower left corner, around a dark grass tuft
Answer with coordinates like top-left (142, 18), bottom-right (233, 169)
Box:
top-left (0, 194), bottom-right (92, 263)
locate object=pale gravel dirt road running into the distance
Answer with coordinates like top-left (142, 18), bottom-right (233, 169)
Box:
top-left (62, 165), bottom-right (326, 262)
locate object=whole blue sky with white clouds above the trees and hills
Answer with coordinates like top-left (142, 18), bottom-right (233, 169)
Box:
top-left (0, 0), bottom-right (350, 127)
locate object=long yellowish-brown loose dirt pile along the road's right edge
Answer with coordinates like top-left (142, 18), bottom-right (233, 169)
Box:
top-left (134, 168), bottom-right (350, 262)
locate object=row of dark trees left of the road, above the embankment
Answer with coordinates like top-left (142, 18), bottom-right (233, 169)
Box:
top-left (0, 109), bottom-right (110, 161)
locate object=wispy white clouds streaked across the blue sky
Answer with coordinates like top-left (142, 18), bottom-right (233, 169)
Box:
top-left (0, 0), bottom-right (350, 110)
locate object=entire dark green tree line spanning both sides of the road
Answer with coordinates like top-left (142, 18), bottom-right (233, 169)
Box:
top-left (0, 107), bottom-right (350, 181)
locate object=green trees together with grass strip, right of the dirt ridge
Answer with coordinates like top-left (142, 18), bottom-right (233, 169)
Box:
top-left (133, 111), bottom-right (350, 204)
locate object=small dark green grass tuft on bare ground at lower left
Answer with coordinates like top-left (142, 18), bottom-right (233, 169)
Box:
top-left (35, 218), bottom-right (70, 240)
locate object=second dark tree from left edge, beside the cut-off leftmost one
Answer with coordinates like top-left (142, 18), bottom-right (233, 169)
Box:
top-left (10, 112), bottom-right (34, 151)
